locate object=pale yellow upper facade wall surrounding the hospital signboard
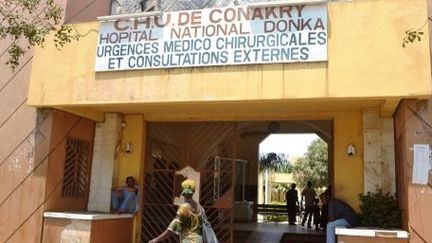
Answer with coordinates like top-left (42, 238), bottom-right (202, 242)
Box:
top-left (28, 0), bottom-right (432, 106)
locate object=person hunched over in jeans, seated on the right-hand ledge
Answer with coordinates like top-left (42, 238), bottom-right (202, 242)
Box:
top-left (322, 193), bottom-right (358, 243)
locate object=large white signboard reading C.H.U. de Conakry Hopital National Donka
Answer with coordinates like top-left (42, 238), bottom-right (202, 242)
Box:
top-left (95, 4), bottom-right (327, 71)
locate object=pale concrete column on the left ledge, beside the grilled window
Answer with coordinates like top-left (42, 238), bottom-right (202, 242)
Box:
top-left (87, 114), bottom-right (121, 212)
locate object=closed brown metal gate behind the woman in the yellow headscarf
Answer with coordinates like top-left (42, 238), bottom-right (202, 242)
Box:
top-left (141, 122), bottom-right (236, 243)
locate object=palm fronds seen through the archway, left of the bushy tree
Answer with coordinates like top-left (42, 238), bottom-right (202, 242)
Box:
top-left (259, 153), bottom-right (292, 173)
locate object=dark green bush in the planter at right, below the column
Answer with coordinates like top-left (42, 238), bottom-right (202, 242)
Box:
top-left (359, 189), bottom-right (402, 229)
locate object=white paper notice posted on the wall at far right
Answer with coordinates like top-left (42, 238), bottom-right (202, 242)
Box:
top-left (412, 144), bottom-right (430, 185)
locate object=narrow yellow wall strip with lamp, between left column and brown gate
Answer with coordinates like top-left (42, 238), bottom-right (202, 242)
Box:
top-left (117, 115), bottom-right (144, 186)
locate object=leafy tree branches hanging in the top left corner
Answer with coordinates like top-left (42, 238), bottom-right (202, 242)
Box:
top-left (0, 0), bottom-right (78, 71)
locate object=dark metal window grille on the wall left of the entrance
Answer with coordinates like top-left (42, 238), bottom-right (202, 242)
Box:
top-left (62, 137), bottom-right (91, 197)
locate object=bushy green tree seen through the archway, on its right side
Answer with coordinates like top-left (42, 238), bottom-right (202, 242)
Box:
top-left (292, 138), bottom-right (329, 187)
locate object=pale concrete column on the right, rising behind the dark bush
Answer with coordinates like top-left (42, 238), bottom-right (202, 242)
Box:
top-left (363, 109), bottom-right (396, 193)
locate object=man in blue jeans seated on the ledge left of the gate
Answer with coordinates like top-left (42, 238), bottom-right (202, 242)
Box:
top-left (111, 176), bottom-right (139, 213)
